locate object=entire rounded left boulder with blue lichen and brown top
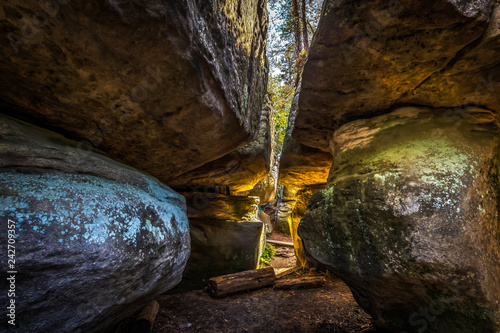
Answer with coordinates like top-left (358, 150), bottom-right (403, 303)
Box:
top-left (0, 116), bottom-right (190, 332)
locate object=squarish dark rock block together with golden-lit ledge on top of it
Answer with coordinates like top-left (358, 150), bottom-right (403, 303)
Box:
top-left (172, 191), bottom-right (266, 293)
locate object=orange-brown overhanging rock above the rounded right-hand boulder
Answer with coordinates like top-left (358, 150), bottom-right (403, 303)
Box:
top-left (293, 0), bottom-right (500, 151)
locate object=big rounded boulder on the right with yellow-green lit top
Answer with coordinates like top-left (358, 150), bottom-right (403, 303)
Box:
top-left (298, 107), bottom-right (500, 332)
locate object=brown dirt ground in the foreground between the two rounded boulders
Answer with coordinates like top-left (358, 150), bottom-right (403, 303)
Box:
top-left (152, 277), bottom-right (374, 333)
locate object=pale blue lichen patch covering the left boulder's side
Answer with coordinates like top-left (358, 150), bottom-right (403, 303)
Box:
top-left (0, 172), bottom-right (188, 246)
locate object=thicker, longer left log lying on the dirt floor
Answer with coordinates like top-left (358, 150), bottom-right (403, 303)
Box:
top-left (208, 267), bottom-right (276, 298)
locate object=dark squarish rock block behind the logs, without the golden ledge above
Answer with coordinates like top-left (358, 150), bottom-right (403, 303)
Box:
top-left (169, 218), bottom-right (265, 292)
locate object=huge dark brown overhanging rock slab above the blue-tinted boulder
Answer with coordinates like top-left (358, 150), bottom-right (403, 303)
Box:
top-left (0, 0), bottom-right (267, 183)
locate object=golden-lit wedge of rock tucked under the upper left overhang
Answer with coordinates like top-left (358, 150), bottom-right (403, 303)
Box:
top-left (166, 94), bottom-right (274, 192)
